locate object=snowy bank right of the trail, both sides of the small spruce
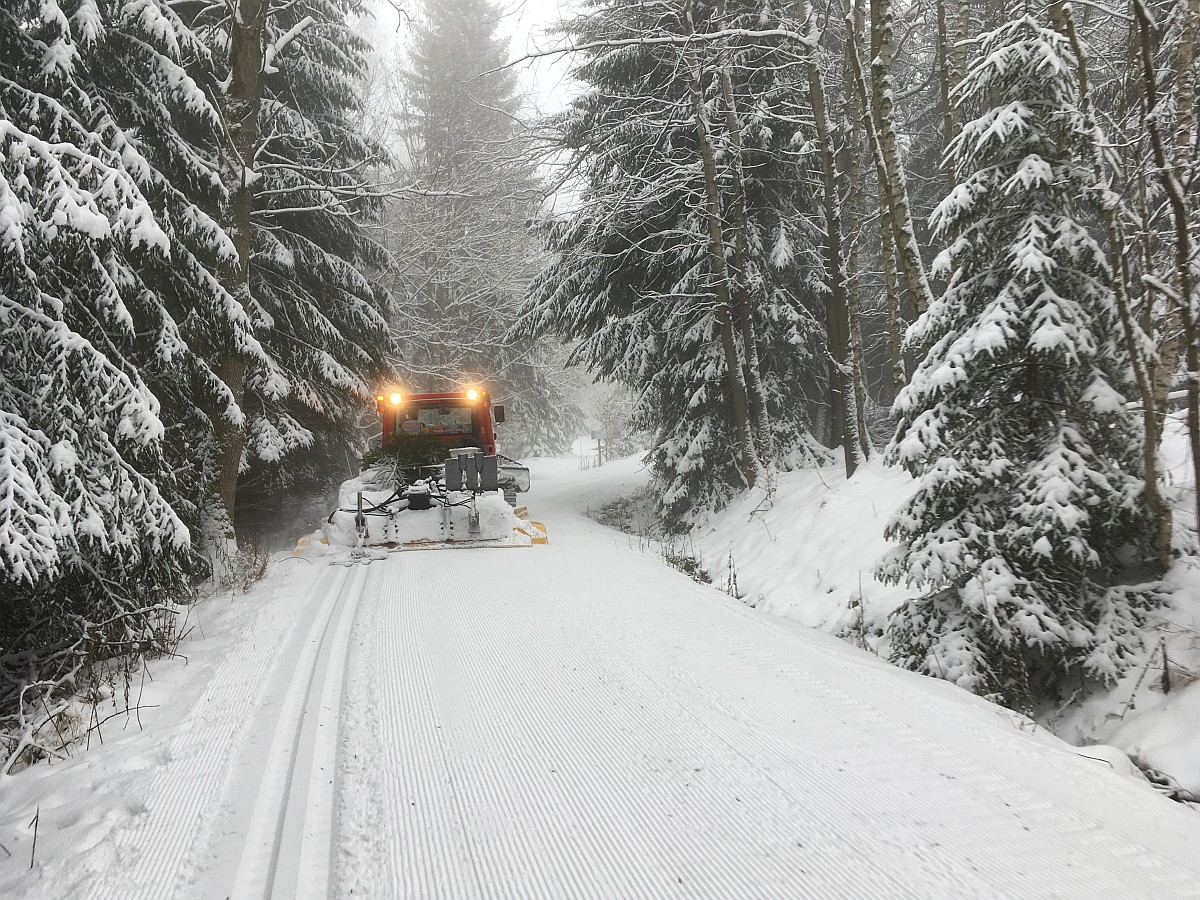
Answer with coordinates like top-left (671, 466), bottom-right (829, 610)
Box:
top-left (690, 419), bottom-right (1200, 798)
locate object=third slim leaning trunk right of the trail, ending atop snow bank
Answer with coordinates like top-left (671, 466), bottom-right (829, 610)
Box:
top-left (796, 0), bottom-right (862, 478)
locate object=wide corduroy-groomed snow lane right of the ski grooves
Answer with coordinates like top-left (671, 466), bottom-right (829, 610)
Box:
top-left (324, 460), bottom-right (1200, 899)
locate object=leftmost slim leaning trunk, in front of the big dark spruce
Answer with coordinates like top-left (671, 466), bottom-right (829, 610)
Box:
top-left (684, 0), bottom-right (761, 487)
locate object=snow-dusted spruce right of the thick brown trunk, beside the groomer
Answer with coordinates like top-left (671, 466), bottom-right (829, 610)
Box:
top-left (247, 0), bottom-right (395, 494)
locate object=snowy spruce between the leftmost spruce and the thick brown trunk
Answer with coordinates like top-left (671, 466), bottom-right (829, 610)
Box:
top-left (77, 0), bottom-right (282, 559)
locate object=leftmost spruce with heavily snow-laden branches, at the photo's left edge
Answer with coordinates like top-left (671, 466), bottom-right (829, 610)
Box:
top-left (0, 0), bottom-right (202, 748)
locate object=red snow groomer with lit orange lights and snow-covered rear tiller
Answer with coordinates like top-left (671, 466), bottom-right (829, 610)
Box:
top-left (325, 388), bottom-right (546, 550)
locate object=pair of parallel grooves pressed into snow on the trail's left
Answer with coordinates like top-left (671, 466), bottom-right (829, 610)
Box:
top-left (230, 566), bottom-right (367, 900)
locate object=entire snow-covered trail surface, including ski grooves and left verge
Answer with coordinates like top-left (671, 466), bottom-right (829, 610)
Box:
top-left (7, 461), bottom-right (1200, 900)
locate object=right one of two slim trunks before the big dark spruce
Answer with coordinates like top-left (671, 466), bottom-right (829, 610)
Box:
top-left (716, 0), bottom-right (774, 464)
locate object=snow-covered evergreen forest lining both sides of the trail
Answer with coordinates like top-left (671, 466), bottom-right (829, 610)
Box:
top-left (0, 0), bottom-right (1200, 758)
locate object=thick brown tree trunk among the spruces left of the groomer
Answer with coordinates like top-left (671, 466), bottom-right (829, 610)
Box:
top-left (212, 0), bottom-right (270, 538)
